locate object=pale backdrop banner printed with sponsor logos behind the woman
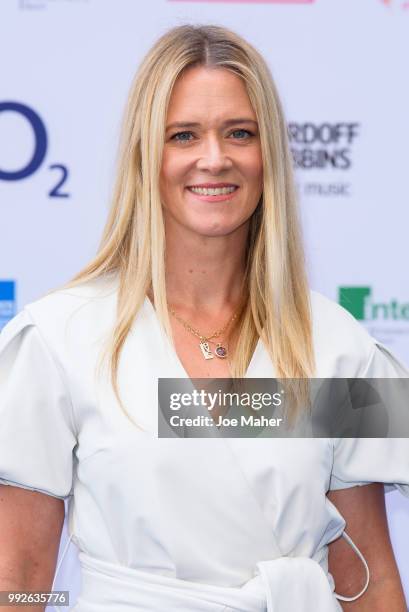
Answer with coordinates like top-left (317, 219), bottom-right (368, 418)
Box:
top-left (0, 0), bottom-right (409, 603)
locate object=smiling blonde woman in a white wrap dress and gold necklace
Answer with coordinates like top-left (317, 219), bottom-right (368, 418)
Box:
top-left (0, 25), bottom-right (409, 612)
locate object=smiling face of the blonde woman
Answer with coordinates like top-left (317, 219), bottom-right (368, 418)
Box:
top-left (160, 67), bottom-right (263, 236)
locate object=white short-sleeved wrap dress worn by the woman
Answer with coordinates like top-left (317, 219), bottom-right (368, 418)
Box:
top-left (0, 277), bottom-right (409, 612)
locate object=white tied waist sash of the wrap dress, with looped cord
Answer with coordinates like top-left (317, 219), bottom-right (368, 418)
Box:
top-left (53, 531), bottom-right (370, 612)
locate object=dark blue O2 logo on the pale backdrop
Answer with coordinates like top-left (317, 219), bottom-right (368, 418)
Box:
top-left (0, 102), bottom-right (70, 198)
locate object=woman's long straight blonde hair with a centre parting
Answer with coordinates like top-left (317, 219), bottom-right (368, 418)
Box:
top-left (52, 25), bottom-right (315, 426)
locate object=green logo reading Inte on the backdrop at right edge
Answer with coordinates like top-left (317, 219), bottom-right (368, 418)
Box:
top-left (338, 286), bottom-right (409, 321)
